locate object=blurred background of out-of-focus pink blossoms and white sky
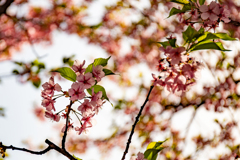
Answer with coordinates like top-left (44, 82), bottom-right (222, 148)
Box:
top-left (0, 0), bottom-right (240, 160)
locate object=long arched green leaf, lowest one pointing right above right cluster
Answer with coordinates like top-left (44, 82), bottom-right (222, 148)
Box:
top-left (190, 41), bottom-right (230, 51)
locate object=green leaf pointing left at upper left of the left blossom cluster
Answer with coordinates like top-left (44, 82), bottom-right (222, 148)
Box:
top-left (52, 67), bottom-right (77, 82)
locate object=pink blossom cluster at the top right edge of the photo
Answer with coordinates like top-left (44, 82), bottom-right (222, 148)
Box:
top-left (178, 1), bottom-right (230, 29)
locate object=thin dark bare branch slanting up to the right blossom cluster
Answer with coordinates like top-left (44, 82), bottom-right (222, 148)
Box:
top-left (122, 85), bottom-right (154, 160)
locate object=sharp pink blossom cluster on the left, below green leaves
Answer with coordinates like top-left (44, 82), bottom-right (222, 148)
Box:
top-left (41, 60), bottom-right (105, 134)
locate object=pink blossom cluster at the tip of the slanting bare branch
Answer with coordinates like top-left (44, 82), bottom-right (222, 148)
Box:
top-left (152, 46), bottom-right (202, 93)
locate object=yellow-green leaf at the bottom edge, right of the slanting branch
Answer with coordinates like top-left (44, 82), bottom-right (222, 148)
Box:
top-left (144, 141), bottom-right (165, 160)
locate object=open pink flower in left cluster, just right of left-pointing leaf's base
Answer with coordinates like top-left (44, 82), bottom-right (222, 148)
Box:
top-left (77, 72), bottom-right (95, 89)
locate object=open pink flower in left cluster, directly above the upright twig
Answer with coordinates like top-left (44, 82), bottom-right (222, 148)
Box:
top-left (68, 82), bottom-right (86, 101)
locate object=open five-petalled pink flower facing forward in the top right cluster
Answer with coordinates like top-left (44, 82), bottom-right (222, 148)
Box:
top-left (200, 1), bottom-right (220, 21)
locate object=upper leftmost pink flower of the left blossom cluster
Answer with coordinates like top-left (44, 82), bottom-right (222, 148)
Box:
top-left (42, 77), bottom-right (62, 96)
